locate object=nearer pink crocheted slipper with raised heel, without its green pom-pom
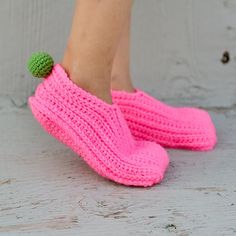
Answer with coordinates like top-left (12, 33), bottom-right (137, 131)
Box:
top-left (29, 64), bottom-right (169, 186)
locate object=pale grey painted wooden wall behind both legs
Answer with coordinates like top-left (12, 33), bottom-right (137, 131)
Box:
top-left (0, 0), bottom-right (236, 109)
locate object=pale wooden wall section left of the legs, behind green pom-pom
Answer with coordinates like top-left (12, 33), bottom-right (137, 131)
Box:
top-left (0, 0), bottom-right (74, 107)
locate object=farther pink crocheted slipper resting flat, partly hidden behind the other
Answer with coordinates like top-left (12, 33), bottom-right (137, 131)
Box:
top-left (112, 89), bottom-right (217, 151)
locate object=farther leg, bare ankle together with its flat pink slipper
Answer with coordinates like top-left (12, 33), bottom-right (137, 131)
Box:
top-left (111, 1), bottom-right (217, 150)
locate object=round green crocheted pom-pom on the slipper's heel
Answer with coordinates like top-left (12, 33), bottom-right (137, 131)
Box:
top-left (28, 52), bottom-right (54, 78)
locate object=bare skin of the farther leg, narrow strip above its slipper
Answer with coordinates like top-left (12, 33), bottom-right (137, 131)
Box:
top-left (111, 9), bottom-right (134, 92)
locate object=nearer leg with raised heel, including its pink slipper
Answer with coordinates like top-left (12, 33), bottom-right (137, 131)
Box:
top-left (29, 0), bottom-right (169, 186)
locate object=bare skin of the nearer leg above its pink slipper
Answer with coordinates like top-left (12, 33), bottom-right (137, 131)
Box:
top-left (61, 0), bottom-right (132, 104)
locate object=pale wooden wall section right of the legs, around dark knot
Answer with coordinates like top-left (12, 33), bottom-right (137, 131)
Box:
top-left (133, 0), bottom-right (236, 107)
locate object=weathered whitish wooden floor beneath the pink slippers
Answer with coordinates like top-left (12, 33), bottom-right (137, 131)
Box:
top-left (0, 107), bottom-right (236, 236)
